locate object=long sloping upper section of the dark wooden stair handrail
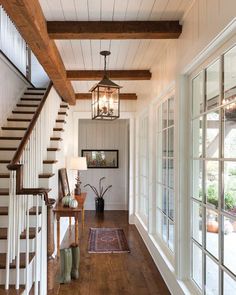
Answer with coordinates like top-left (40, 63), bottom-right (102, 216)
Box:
top-left (7, 82), bottom-right (53, 170)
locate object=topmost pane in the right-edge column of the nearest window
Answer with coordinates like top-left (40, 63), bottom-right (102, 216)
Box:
top-left (224, 46), bottom-right (236, 94)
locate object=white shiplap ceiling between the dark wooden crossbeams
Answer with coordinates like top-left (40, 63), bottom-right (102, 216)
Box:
top-left (40, 0), bottom-right (192, 92)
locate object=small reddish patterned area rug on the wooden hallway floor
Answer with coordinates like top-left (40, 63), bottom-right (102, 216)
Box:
top-left (88, 228), bottom-right (130, 253)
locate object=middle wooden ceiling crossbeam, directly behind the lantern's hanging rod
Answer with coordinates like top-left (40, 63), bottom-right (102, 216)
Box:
top-left (67, 70), bottom-right (152, 81)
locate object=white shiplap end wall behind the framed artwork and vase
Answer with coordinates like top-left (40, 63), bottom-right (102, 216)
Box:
top-left (78, 120), bottom-right (128, 210)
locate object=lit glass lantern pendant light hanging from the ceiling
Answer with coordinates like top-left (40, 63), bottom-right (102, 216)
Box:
top-left (90, 51), bottom-right (121, 120)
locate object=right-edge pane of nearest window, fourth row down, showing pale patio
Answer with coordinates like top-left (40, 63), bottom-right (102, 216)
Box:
top-left (224, 217), bottom-right (236, 274)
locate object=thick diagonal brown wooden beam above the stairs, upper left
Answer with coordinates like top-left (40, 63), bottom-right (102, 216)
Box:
top-left (1, 0), bottom-right (75, 104)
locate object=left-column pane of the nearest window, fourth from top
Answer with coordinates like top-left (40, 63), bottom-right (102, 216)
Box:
top-left (192, 202), bottom-right (203, 244)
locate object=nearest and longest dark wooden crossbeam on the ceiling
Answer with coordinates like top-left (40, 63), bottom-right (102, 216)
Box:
top-left (47, 21), bottom-right (182, 40)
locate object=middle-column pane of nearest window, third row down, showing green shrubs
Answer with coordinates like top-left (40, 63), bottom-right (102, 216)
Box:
top-left (205, 161), bottom-right (219, 207)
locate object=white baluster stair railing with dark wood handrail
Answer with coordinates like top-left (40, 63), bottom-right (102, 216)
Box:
top-left (5, 84), bottom-right (61, 295)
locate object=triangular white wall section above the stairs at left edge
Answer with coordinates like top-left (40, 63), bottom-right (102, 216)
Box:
top-left (0, 54), bottom-right (27, 133)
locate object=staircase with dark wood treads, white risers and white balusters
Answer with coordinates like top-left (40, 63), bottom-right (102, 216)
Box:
top-left (0, 88), bottom-right (68, 295)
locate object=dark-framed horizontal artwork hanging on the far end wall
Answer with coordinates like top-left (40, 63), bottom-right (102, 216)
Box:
top-left (82, 150), bottom-right (119, 168)
